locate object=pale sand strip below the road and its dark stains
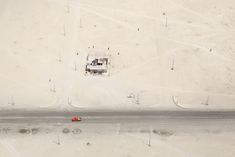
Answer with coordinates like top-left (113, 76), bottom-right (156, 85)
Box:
top-left (0, 124), bottom-right (235, 157)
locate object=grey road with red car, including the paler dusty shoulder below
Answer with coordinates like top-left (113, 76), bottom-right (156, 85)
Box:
top-left (0, 111), bottom-right (235, 134)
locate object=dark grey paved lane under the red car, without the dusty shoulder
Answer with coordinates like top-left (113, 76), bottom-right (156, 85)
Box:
top-left (0, 111), bottom-right (235, 123)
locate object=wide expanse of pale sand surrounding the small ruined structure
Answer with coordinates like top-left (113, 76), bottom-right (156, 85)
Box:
top-left (0, 0), bottom-right (235, 110)
